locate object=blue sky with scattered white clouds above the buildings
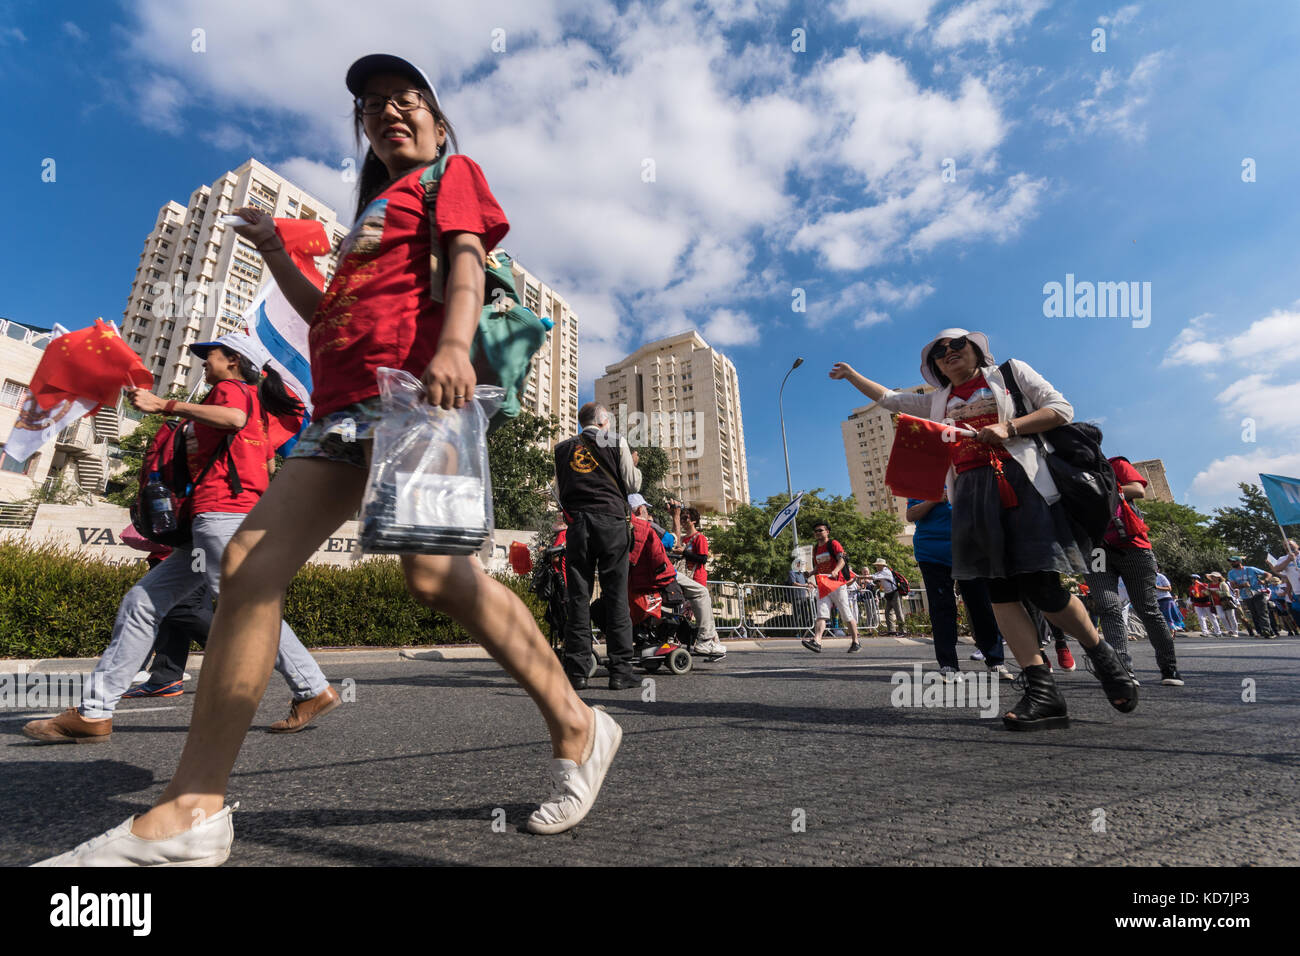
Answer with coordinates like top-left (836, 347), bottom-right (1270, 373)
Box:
top-left (0, 0), bottom-right (1300, 509)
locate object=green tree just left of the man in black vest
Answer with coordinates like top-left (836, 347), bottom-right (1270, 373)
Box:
top-left (488, 411), bottom-right (560, 531)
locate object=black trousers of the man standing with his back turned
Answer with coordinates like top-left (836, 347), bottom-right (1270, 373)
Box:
top-left (564, 511), bottom-right (632, 678)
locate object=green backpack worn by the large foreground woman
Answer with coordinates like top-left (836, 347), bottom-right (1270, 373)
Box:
top-left (420, 155), bottom-right (555, 431)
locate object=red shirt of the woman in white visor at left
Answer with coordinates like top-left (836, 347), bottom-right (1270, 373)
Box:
top-left (185, 380), bottom-right (276, 515)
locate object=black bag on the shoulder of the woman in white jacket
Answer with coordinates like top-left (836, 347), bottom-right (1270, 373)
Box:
top-left (998, 359), bottom-right (1119, 544)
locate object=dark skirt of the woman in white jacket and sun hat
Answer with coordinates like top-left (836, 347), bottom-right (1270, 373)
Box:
top-left (953, 459), bottom-right (1092, 581)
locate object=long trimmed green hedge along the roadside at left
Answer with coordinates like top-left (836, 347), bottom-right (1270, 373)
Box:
top-left (0, 541), bottom-right (547, 658)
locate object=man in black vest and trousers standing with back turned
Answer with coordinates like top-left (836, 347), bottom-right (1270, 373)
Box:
top-left (555, 402), bottom-right (641, 691)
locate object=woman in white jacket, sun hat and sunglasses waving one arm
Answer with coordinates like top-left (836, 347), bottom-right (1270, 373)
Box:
top-left (831, 329), bottom-right (1138, 730)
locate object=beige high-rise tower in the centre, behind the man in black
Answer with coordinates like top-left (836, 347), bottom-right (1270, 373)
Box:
top-left (595, 330), bottom-right (749, 514)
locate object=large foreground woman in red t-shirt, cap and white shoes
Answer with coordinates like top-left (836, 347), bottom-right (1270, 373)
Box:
top-left (47, 55), bottom-right (621, 865)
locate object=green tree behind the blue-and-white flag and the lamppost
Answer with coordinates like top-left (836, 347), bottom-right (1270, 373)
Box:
top-left (710, 488), bottom-right (920, 587)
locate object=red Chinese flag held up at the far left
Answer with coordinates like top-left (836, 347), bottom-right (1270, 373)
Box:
top-left (30, 319), bottom-right (153, 414)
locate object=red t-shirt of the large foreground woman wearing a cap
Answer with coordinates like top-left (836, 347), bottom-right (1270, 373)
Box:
top-left (308, 155), bottom-right (510, 420)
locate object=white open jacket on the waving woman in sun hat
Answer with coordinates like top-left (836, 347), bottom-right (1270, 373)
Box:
top-left (879, 359), bottom-right (1074, 505)
